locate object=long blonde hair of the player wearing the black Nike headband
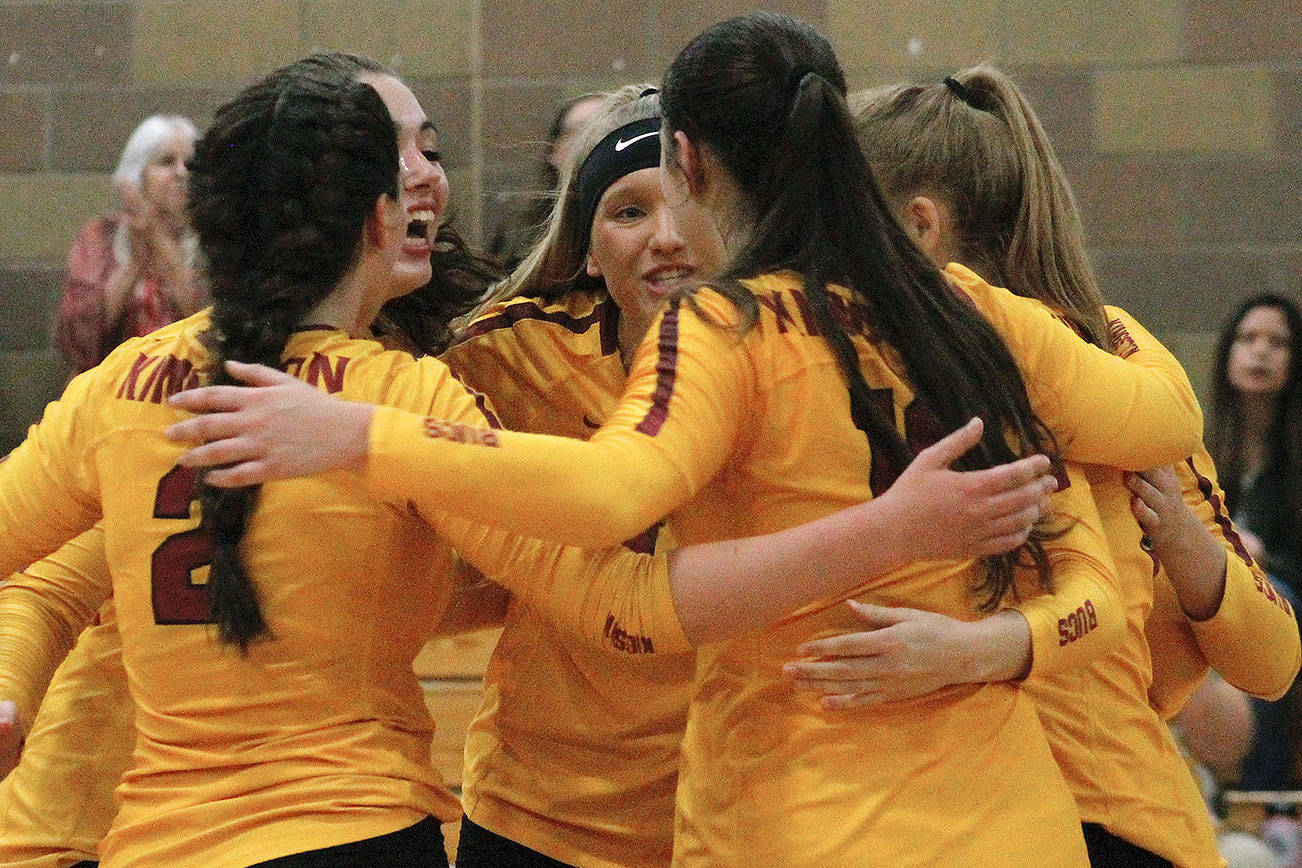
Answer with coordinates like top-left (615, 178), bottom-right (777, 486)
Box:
top-left (474, 85), bottom-right (660, 315)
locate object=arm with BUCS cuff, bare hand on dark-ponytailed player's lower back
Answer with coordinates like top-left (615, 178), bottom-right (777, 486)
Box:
top-left (784, 467), bottom-right (1125, 708)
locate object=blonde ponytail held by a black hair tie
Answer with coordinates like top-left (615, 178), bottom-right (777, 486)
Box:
top-left (850, 64), bottom-right (1112, 349)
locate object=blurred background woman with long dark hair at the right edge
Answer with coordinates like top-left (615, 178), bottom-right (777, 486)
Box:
top-left (1207, 294), bottom-right (1302, 790)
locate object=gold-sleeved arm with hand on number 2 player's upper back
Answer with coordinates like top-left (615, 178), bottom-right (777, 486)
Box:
top-left (169, 295), bottom-right (759, 547)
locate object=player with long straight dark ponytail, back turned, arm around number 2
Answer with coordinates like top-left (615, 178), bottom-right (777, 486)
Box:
top-left (165, 14), bottom-right (1218, 864)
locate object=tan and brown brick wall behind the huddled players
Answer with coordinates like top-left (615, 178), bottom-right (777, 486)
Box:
top-left (0, 0), bottom-right (1302, 446)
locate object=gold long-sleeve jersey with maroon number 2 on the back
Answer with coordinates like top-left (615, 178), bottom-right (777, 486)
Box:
top-left (0, 314), bottom-right (686, 868)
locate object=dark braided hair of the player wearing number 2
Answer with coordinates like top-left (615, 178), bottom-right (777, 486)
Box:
top-left (189, 55), bottom-right (398, 652)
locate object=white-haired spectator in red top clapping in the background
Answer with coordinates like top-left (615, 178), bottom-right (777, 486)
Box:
top-left (55, 115), bottom-right (204, 372)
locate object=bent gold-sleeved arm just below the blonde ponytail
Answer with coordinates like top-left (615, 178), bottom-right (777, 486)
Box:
top-left (945, 265), bottom-right (1203, 470)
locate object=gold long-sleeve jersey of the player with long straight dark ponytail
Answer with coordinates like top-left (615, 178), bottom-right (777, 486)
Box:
top-left (367, 273), bottom-right (1200, 865)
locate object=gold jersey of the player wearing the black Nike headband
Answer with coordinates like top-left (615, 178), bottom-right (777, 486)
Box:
top-left (443, 293), bottom-right (695, 868)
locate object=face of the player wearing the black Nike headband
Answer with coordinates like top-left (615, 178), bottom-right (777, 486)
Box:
top-left (586, 167), bottom-right (715, 349)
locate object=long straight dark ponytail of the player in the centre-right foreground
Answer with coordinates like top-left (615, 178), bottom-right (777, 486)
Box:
top-left (660, 12), bottom-right (1056, 610)
